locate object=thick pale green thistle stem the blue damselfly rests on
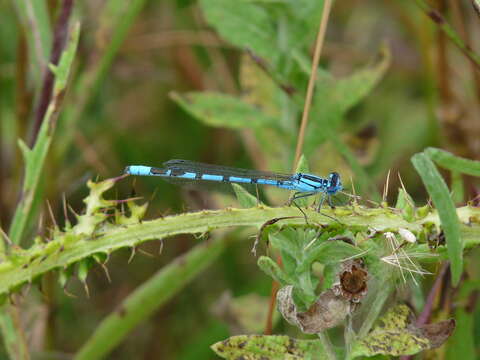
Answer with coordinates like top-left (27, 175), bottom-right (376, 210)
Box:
top-left (0, 202), bottom-right (480, 294)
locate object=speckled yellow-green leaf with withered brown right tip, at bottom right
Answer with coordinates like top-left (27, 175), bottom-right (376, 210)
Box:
top-left (351, 305), bottom-right (455, 358)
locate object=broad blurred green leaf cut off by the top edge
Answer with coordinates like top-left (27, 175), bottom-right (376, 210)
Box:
top-left (200, 0), bottom-right (280, 65)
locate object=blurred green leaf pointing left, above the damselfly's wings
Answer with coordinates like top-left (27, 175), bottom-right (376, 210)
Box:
top-left (170, 92), bottom-right (276, 129)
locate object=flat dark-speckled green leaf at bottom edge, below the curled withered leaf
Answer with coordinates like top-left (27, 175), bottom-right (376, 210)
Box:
top-left (212, 335), bottom-right (326, 360)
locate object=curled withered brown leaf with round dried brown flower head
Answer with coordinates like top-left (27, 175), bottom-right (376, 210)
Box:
top-left (277, 259), bottom-right (368, 334)
